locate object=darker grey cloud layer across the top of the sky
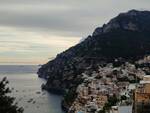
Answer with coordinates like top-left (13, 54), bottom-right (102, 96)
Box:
top-left (0, 0), bottom-right (150, 37)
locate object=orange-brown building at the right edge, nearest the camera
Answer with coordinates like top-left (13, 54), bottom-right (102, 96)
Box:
top-left (133, 76), bottom-right (150, 113)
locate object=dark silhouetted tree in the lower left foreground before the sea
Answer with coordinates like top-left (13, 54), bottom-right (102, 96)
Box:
top-left (0, 77), bottom-right (23, 113)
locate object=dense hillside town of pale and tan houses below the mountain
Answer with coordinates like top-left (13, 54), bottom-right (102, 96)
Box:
top-left (69, 56), bottom-right (150, 113)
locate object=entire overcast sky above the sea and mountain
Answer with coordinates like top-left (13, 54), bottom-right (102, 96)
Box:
top-left (0, 0), bottom-right (150, 64)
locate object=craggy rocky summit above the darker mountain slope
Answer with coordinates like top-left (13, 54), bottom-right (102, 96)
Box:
top-left (93, 10), bottom-right (150, 36)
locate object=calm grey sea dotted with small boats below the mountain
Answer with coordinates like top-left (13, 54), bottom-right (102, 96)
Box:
top-left (0, 65), bottom-right (63, 113)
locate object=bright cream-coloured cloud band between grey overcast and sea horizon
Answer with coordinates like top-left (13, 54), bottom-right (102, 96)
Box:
top-left (0, 27), bottom-right (79, 63)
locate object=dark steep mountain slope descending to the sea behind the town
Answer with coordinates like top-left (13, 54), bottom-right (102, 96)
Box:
top-left (38, 10), bottom-right (150, 92)
